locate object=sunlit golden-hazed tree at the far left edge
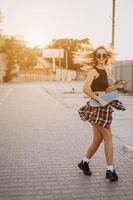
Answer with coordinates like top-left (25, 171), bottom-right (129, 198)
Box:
top-left (1, 36), bottom-right (41, 82)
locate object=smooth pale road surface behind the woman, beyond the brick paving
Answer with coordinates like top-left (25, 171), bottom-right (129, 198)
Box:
top-left (43, 81), bottom-right (133, 147)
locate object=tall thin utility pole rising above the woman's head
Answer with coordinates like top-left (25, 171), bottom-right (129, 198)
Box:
top-left (112, 0), bottom-right (115, 48)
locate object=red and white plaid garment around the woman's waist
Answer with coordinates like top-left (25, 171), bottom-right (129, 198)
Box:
top-left (78, 100), bottom-right (125, 129)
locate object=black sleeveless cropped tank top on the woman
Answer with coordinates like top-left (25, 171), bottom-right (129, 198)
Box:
top-left (91, 67), bottom-right (109, 92)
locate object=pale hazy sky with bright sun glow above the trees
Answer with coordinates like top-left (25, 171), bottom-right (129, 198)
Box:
top-left (0, 0), bottom-right (133, 60)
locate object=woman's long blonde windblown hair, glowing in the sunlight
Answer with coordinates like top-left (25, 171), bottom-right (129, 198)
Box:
top-left (73, 44), bottom-right (116, 71)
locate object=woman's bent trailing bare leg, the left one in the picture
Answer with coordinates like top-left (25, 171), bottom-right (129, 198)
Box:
top-left (86, 124), bottom-right (102, 159)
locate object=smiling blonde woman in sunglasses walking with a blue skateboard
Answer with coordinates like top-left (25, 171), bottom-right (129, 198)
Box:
top-left (75, 46), bottom-right (127, 181)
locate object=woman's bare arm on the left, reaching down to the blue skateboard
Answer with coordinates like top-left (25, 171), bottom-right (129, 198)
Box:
top-left (83, 69), bottom-right (107, 106)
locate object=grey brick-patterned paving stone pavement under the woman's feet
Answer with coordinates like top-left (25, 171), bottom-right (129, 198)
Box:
top-left (0, 84), bottom-right (133, 200)
